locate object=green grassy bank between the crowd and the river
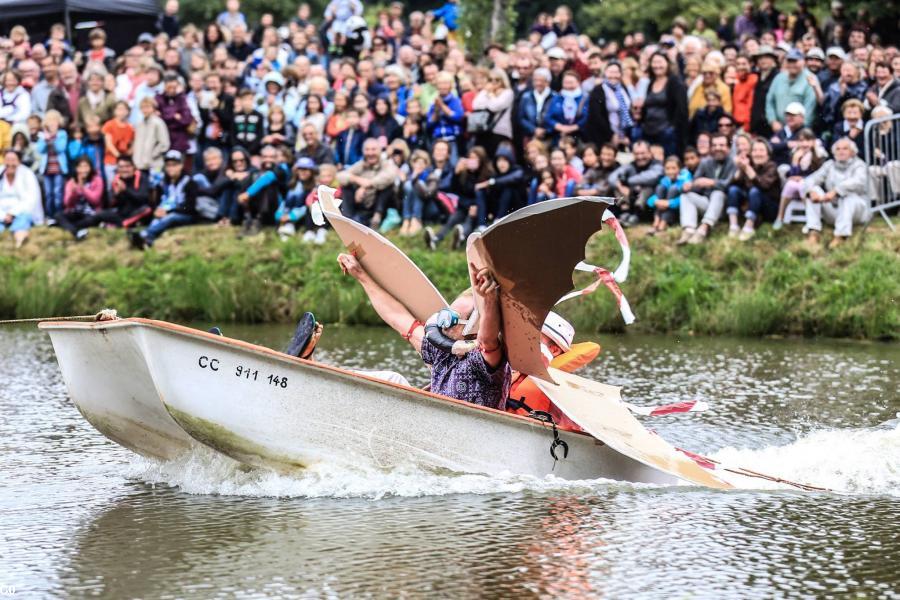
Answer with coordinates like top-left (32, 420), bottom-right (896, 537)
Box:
top-left (0, 224), bottom-right (900, 340)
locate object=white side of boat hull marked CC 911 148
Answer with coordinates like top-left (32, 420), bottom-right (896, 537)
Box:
top-left (42, 319), bottom-right (678, 483)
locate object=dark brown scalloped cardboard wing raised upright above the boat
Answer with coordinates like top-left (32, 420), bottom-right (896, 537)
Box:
top-left (466, 196), bottom-right (614, 382)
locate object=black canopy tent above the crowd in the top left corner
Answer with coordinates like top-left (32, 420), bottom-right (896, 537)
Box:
top-left (0, 0), bottom-right (161, 51)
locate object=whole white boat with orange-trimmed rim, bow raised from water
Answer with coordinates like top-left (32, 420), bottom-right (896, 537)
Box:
top-left (40, 319), bottom-right (692, 484)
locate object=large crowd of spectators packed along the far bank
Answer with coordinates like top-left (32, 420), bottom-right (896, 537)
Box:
top-left (0, 0), bottom-right (900, 249)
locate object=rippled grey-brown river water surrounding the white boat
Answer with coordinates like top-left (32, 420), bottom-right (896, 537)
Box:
top-left (0, 326), bottom-right (900, 598)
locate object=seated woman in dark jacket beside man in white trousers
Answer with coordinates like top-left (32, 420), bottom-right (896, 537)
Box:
top-left (727, 139), bottom-right (781, 242)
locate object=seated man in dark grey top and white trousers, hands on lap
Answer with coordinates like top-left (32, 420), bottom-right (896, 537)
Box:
top-left (677, 133), bottom-right (735, 245)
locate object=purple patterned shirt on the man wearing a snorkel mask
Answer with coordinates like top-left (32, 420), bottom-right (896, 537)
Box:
top-left (422, 338), bottom-right (512, 410)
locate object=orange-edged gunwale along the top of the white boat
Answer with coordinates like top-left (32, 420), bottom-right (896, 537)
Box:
top-left (38, 317), bottom-right (593, 439)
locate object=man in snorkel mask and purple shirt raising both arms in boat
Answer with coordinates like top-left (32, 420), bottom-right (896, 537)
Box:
top-left (338, 254), bottom-right (512, 410)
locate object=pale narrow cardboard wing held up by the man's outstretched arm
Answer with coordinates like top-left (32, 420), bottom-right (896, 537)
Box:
top-left (316, 185), bottom-right (449, 323)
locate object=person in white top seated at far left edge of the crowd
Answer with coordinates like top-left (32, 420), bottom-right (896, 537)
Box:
top-left (0, 150), bottom-right (44, 249)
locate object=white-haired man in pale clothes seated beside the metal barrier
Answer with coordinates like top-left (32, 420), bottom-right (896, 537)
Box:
top-left (803, 138), bottom-right (872, 251)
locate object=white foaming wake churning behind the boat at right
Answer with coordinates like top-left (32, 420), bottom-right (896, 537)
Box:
top-left (711, 419), bottom-right (900, 497)
